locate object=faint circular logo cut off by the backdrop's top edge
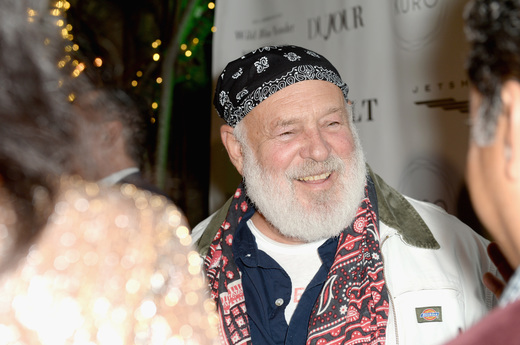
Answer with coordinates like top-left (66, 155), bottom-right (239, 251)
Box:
top-left (394, 0), bottom-right (448, 50)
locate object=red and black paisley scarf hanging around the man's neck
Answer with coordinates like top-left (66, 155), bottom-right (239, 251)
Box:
top-left (204, 183), bottom-right (388, 345)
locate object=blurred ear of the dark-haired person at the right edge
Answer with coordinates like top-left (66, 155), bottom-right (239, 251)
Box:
top-left (499, 80), bottom-right (520, 180)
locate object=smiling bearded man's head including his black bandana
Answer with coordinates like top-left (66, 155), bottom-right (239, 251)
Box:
top-left (214, 46), bottom-right (366, 243)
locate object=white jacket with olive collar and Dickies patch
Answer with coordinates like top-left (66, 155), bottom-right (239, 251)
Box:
top-left (193, 165), bottom-right (497, 345)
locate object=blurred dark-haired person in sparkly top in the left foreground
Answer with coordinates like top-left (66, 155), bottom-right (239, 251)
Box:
top-left (0, 0), bottom-right (216, 344)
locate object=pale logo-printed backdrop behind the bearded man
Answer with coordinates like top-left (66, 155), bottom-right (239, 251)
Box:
top-left (210, 0), bottom-right (469, 220)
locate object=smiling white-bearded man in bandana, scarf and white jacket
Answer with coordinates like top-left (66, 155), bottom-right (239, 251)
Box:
top-left (193, 46), bottom-right (496, 344)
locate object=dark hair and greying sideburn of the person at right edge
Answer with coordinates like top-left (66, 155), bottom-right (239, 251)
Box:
top-left (464, 0), bottom-right (520, 145)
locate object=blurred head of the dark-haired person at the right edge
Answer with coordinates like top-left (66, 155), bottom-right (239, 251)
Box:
top-left (465, 0), bottom-right (520, 267)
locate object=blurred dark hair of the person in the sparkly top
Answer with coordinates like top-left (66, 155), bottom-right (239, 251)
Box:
top-left (0, 0), bottom-right (86, 255)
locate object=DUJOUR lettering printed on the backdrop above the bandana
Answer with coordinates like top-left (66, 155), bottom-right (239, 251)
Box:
top-left (307, 6), bottom-right (365, 40)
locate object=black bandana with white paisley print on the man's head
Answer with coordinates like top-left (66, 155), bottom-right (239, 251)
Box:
top-left (213, 46), bottom-right (348, 127)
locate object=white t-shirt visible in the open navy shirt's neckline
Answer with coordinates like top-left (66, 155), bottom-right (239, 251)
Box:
top-left (247, 219), bottom-right (326, 324)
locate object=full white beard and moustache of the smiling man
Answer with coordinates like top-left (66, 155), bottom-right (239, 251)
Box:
top-left (242, 134), bottom-right (366, 242)
